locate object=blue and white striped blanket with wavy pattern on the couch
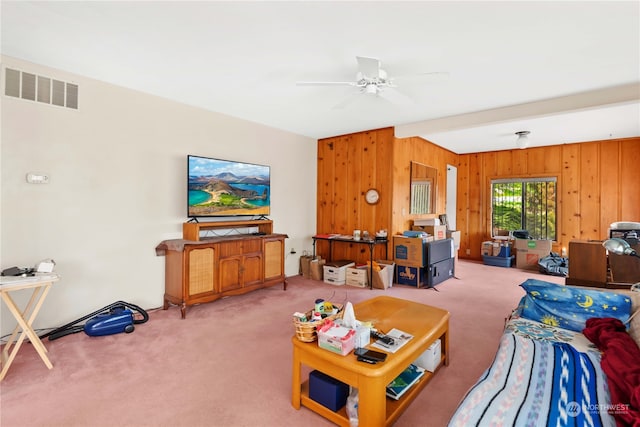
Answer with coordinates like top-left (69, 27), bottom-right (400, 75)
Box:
top-left (449, 332), bottom-right (615, 427)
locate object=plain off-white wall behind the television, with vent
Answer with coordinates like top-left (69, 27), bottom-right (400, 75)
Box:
top-left (0, 56), bottom-right (317, 335)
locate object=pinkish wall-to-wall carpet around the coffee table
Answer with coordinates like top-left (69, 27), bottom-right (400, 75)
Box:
top-left (0, 261), bottom-right (564, 427)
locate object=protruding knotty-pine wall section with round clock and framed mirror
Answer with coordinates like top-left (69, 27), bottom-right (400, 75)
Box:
top-left (316, 128), bottom-right (458, 263)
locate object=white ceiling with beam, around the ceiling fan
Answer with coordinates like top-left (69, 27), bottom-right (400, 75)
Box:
top-left (0, 0), bottom-right (640, 153)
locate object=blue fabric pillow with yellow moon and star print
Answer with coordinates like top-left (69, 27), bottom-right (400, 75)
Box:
top-left (520, 279), bottom-right (631, 332)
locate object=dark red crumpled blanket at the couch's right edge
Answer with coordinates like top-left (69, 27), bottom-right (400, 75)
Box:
top-left (582, 318), bottom-right (640, 427)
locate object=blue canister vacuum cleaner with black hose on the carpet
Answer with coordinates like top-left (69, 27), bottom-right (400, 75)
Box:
top-left (40, 301), bottom-right (149, 341)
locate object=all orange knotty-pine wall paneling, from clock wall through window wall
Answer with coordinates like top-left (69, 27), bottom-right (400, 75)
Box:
top-left (316, 128), bottom-right (640, 263)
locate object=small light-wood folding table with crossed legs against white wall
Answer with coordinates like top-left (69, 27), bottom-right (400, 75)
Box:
top-left (0, 274), bottom-right (60, 381)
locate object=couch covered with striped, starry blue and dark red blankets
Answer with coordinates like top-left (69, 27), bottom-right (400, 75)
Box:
top-left (449, 279), bottom-right (640, 427)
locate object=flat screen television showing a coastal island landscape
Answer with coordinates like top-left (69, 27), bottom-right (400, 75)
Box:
top-left (187, 155), bottom-right (271, 218)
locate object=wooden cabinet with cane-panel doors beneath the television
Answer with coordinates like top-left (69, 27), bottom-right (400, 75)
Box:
top-left (156, 220), bottom-right (288, 319)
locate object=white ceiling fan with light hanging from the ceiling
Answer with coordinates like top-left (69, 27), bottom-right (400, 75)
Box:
top-left (296, 56), bottom-right (448, 108)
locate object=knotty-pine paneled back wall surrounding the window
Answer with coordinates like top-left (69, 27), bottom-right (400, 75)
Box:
top-left (457, 138), bottom-right (640, 259)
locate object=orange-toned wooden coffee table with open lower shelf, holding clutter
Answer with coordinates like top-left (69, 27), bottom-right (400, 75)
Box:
top-left (291, 296), bottom-right (449, 427)
